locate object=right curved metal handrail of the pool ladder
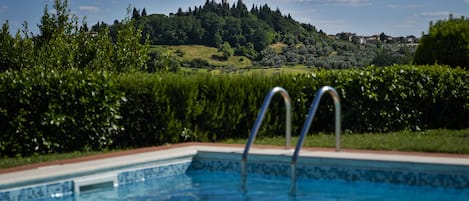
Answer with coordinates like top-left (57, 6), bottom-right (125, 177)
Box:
top-left (290, 86), bottom-right (342, 193)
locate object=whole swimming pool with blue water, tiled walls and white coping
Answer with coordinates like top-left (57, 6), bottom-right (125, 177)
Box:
top-left (0, 146), bottom-right (469, 201)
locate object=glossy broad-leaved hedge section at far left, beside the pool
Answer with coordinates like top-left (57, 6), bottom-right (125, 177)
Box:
top-left (0, 68), bottom-right (123, 156)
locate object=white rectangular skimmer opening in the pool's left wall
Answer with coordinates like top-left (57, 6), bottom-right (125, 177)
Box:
top-left (73, 173), bottom-right (119, 195)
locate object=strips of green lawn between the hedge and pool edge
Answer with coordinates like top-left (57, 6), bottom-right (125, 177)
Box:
top-left (0, 129), bottom-right (469, 169)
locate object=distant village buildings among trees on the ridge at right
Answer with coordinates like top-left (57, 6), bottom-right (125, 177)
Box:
top-left (329, 32), bottom-right (419, 47)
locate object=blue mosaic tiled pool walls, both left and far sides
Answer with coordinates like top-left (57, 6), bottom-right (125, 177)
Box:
top-left (0, 153), bottom-right (469, 201)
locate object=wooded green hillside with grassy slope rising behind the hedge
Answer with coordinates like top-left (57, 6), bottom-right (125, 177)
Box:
top-left (110, 0), bottom-right (414, 69)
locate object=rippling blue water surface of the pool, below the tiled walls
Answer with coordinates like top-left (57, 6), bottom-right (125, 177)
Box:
top-left (74, 170), bottom-right (469, 201)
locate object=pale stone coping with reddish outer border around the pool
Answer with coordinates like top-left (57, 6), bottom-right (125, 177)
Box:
top-left (0, 143), bottom-right (469, 186)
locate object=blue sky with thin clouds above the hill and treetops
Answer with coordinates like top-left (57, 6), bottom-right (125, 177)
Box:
top-left (0, 0), bottom-right (469, 37)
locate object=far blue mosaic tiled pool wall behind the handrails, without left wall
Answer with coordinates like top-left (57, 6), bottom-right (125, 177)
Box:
top-left (189, 155), bottom-right (469, 189)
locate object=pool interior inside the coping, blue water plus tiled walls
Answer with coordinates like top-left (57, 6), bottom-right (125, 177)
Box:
top-left (0, 152), bottom-right (469, 201)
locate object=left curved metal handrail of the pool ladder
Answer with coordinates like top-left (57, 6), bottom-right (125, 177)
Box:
top-left (241, 87), bottom-right (291, 181)
